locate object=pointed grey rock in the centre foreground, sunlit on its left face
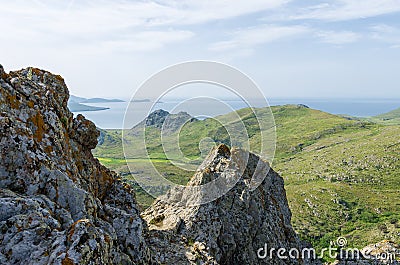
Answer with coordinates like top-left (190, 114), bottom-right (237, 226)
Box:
top-left (142, 145), bottom-right (318, 264)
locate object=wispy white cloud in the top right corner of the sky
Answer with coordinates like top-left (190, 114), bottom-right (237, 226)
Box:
top-left (289, 0), bottom-right (400, 21)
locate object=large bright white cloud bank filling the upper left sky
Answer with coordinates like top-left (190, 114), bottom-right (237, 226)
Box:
top-left (0, 0), bottom-right (288, 51)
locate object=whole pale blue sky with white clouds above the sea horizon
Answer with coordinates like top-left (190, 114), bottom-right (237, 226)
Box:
top-left (0, 0), bottom-right (400, 98)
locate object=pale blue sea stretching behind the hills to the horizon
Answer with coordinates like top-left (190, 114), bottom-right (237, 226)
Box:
top-left (74, 98), bottom-right (400, 129)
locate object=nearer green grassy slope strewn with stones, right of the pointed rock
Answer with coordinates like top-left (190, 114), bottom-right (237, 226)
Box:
top-left (274, 124), bottom-right (400, 247)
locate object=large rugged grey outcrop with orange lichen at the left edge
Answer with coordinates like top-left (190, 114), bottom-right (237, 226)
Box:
top-left (0, 67), bottom-right (149, 264)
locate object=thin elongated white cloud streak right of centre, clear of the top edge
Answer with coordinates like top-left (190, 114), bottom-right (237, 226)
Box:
top-left (209, 25), bottom-right (309, 51)
